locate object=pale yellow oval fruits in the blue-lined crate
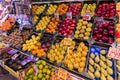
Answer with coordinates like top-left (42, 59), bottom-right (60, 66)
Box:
top-left (88, 46), bottom-right (115, 80)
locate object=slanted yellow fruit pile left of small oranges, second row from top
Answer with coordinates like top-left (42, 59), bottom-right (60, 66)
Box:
top-left (36, 16), bottom-right (50, 31)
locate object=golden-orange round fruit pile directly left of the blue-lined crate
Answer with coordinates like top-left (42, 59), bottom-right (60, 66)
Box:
top-left (64, 42), bottom-right (88, 73)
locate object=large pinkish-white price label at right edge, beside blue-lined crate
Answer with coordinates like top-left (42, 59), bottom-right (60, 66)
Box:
top-left (108, 47), bottom-right (120, 60)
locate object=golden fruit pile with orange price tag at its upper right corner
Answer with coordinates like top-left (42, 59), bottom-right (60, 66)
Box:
top-left (47, 38), bottom-right (75, 64)
